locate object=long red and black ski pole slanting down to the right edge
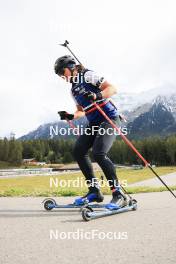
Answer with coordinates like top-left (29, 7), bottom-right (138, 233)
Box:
top-left (92, 102), bottom-right (176, 198)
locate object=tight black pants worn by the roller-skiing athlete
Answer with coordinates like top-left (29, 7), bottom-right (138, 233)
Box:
top-left (73, 117), bottom-right (120, 189)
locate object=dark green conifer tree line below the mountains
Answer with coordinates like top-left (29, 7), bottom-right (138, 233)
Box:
top-left (0, 135), bottom-right (176, 166)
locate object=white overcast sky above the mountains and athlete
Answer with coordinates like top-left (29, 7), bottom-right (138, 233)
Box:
top-left (0, 0), bottom-right (176, 137)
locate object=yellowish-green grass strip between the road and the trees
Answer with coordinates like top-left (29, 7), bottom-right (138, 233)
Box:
top-left (0, 167), bottom-right (176, 197)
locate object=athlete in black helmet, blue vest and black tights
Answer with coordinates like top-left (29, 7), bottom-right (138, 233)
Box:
top-left (54, 55), bottom-right (127, 207)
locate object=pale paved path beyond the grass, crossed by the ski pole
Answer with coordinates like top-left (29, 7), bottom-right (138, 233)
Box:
top-left (129, 172), bottom-right (176, 187)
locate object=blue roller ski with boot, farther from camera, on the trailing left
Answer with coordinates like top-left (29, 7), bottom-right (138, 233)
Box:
top-left (43, 187), bottom-right (105, 211)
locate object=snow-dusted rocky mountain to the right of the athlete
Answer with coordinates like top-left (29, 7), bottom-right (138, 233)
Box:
top-left (126, 91), bottom-right (176, 138)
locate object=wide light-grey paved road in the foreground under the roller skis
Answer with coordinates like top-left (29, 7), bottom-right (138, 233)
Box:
top-left (0, 192), bottom-right (176, 264)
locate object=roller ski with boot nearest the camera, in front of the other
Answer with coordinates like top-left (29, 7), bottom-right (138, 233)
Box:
top-left (82, 187), bottom-right (137, 221)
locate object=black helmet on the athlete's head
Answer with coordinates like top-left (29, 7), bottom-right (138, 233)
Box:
top-left (54, 55), bottom-right (76, 75)
